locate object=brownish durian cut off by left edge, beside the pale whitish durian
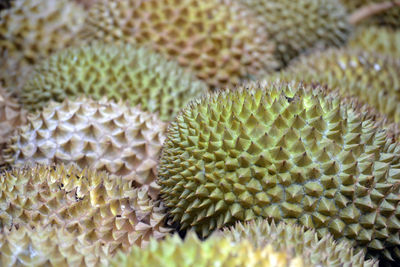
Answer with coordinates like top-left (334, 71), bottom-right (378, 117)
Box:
top-left (0, 86), bottom-right (27, 165)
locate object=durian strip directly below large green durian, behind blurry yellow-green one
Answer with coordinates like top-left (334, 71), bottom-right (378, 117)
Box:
top-left (219, 220), bottom-right (378, 267)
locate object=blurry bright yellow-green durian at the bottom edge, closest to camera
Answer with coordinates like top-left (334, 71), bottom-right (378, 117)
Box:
top-left (109, 233), bottom-right (304, 267)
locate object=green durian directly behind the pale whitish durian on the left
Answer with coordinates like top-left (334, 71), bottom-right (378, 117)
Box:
top-left (21, 43), bottom-right (207, 121)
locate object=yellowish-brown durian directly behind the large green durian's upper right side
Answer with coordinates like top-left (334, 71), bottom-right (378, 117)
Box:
top-left (276, 49), bottom-right (400, 123)
